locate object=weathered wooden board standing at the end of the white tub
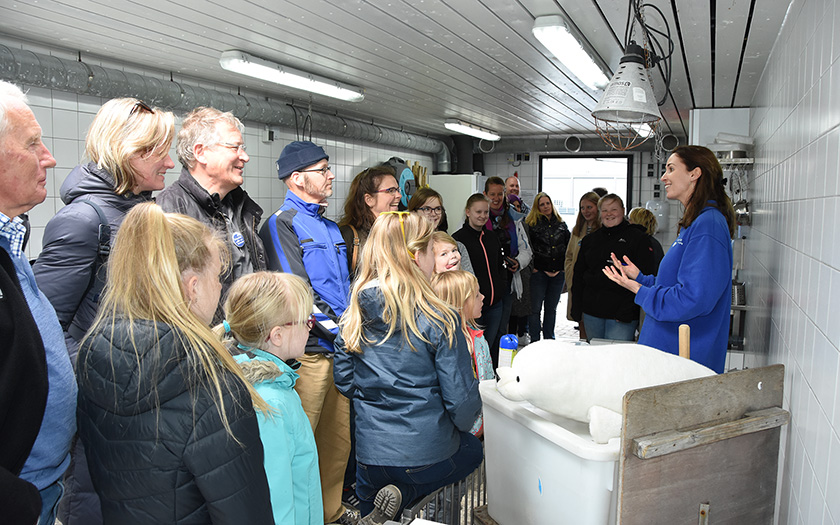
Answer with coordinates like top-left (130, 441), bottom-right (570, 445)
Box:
top-left (618, 365), bottom-right (784, 525)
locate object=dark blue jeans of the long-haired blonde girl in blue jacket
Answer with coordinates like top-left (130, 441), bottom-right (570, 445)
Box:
top-left (356, 432), bottom-right (484, 516)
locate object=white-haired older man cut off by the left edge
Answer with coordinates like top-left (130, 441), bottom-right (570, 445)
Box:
top-left (0, 81), bottom-right (77, 523)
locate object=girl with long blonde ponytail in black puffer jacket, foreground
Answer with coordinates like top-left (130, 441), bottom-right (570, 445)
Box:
top-left (76, 203), bottom-right (272, 524)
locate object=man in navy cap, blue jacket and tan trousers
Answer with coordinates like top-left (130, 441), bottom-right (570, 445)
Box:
top-left (260, 141), bottom-right (359, 524)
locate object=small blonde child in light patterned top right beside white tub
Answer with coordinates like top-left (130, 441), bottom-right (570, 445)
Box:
top-left (432, 270), bottom-right (495, 437)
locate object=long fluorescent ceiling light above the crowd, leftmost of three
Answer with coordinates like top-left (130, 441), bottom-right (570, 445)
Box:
top-left (219, 50), bottom-right (365, 102)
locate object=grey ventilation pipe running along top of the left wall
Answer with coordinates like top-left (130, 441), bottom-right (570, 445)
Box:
top-left (0, 45), bottom-right (452, 173)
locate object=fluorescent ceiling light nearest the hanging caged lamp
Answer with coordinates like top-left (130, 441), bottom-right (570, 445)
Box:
top-left (532, 15), bottom-right (609, 90)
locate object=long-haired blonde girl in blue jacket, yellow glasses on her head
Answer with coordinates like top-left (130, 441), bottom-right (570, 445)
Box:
top-left (335, 212), bottom-right (483, 513)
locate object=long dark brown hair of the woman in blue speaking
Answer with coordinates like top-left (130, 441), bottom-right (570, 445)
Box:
top-left (672, 146), bottom-right (736, 238)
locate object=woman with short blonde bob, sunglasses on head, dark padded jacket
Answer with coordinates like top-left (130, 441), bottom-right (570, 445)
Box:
top-left (32, 98), bottom-right (175, 525)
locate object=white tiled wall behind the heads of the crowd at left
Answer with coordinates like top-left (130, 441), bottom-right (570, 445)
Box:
top-left (22, 86), bottom-right (434, 258)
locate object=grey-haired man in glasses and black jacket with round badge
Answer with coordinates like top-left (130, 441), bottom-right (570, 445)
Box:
top-left (157, 107), bottom-right (266, 324)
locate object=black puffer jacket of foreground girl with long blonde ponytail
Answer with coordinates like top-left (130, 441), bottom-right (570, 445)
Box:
top-left (77, 319), bottom-right (273, 525)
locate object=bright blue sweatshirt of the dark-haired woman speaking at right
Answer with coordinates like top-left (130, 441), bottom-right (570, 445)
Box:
top-left (636, 206), bottom-right (732, 373)
